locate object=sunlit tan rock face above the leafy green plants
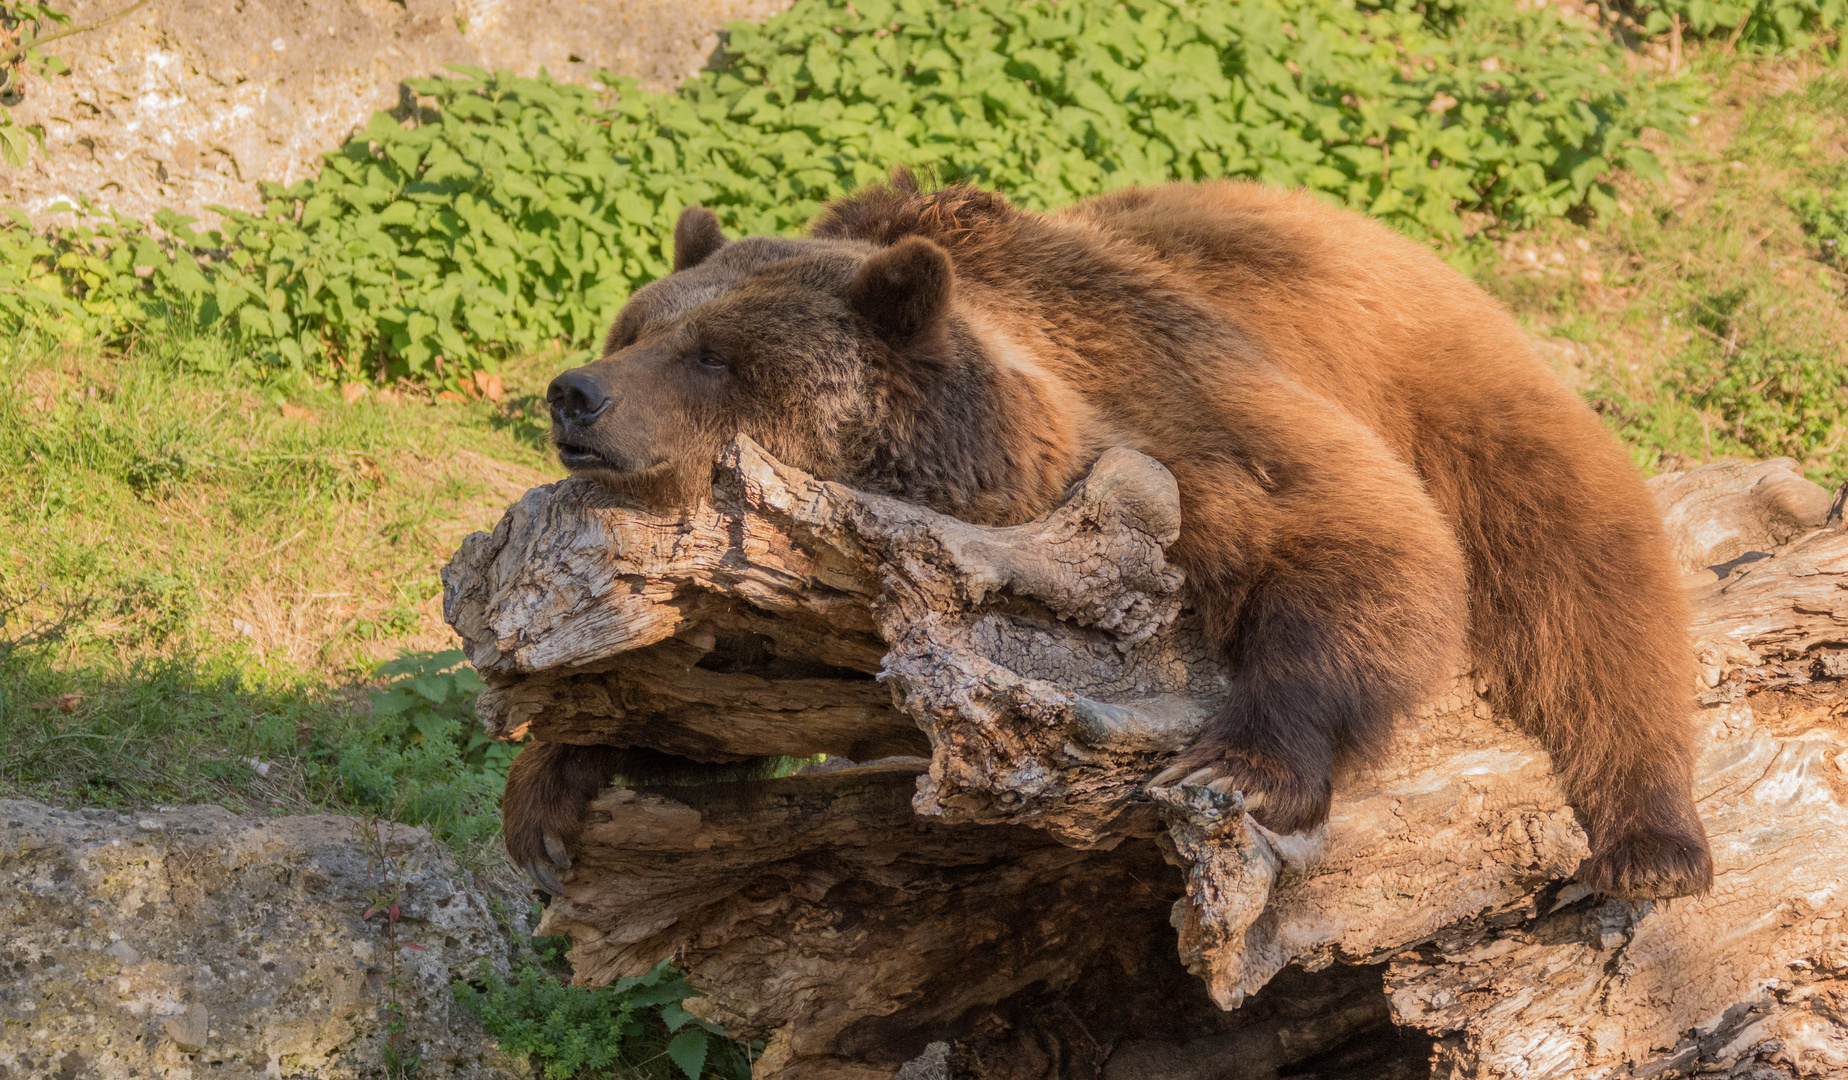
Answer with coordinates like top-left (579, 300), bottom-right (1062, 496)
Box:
top-left (0, 0), bottom-right (789, 218)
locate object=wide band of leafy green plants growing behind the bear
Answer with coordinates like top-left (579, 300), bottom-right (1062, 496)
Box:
top-left (0, 0), bottom-right (1685, 388)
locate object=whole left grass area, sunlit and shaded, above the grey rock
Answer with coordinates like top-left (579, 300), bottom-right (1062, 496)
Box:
top-left (0, 329), bottom-right (558, 858)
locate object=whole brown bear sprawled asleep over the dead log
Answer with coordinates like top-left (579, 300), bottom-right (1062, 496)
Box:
top-left (503, 174), bottom-right (1713, 897)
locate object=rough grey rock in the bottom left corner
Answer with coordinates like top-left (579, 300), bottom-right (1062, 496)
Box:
top-left (0, 801), bottom-right (525, 1080)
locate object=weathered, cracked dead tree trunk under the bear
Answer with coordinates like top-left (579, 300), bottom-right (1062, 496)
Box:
top-left (444, 440), bottom-right (1848, 1080)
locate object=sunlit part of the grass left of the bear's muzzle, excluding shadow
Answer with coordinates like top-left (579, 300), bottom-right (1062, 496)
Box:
top-left (0, 327), bottom-right (558, 675)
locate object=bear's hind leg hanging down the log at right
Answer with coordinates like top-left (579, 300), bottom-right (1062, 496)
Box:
top-left (1449, 401), bottom-right (1713, 899)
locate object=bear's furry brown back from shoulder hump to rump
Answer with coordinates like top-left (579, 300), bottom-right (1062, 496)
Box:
top-left (813, 181), bottom-right (1635, 518)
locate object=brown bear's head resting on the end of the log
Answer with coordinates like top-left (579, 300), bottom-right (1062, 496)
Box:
top-left (545, 207), bottom-right (1063, 522)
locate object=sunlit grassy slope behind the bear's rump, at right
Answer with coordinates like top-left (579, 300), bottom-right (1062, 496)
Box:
top-left (1478, 48), bottom-right (1848, 483)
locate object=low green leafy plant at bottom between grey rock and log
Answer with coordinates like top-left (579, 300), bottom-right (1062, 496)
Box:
top-left (453, 962), bottom-right (752, 1080)
